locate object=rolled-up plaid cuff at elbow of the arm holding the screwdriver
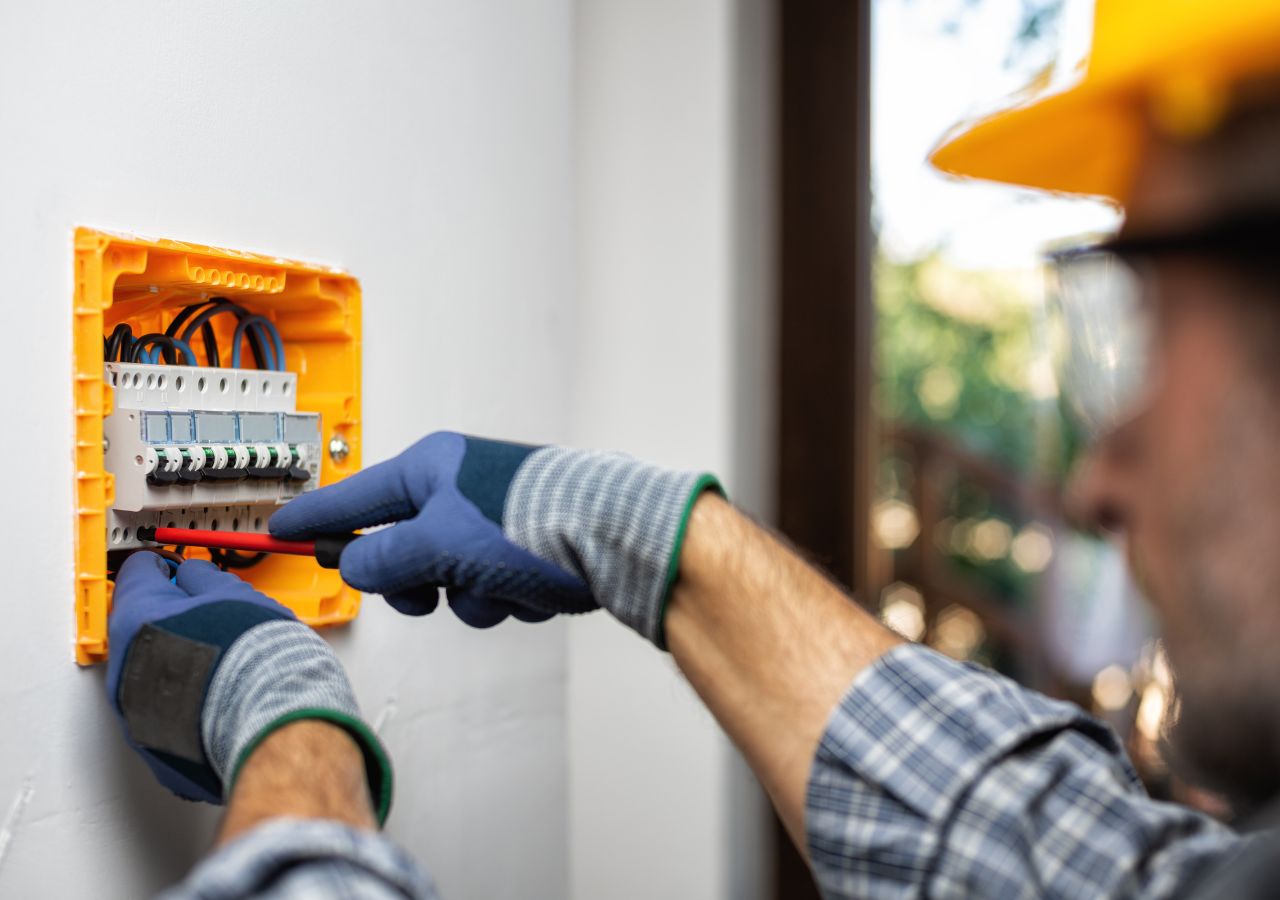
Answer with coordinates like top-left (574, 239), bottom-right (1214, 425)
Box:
top-left (805, 644), bottom-right (1138, 878)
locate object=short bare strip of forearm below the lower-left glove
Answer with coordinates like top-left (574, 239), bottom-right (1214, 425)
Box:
top-left (218, 719), bottom-right (376, 844)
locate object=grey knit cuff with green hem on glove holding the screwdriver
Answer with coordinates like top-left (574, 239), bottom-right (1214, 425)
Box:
top-left (502, 447), bottom-right (723, 649)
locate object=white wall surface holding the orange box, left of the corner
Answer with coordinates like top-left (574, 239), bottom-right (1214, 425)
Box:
top-left (0, 0), bottom-right (575, 899)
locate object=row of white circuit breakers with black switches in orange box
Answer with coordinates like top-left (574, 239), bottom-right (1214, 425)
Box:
top-left (102, 362), bottom-right (320, 550)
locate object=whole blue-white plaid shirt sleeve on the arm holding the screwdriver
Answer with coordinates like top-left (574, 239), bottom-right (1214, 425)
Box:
top-left (806, 644), bottom-right (1243, 897)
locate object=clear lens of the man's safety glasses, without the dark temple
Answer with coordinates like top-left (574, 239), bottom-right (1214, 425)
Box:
top-left (1048, 247), bottom-right (1151, 440)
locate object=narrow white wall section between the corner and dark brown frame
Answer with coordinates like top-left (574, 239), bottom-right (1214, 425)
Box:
top-left (570, 0), bottom-right (773, 900)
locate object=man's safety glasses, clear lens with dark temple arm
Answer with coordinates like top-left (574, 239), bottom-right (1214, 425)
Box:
top-left (1048, 204), bottom-right (1280, 440)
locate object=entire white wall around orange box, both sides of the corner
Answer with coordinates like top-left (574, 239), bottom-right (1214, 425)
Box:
top-left (0, 7), bottom-right (771, 900)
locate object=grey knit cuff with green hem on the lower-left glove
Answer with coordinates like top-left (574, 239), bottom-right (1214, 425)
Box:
top-left (200, 620), bottom-right (392, 823)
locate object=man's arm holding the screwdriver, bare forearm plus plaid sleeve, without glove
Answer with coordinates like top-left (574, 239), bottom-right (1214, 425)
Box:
top-left (666, 504), bottom-right (1238, 897)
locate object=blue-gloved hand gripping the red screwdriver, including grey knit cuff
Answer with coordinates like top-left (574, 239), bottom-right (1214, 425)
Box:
top-left (270, 431), bottom-right (719, 648)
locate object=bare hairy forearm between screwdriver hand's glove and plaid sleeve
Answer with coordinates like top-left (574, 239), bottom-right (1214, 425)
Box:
top-left (666, 493), bottom-right (901, 851)
